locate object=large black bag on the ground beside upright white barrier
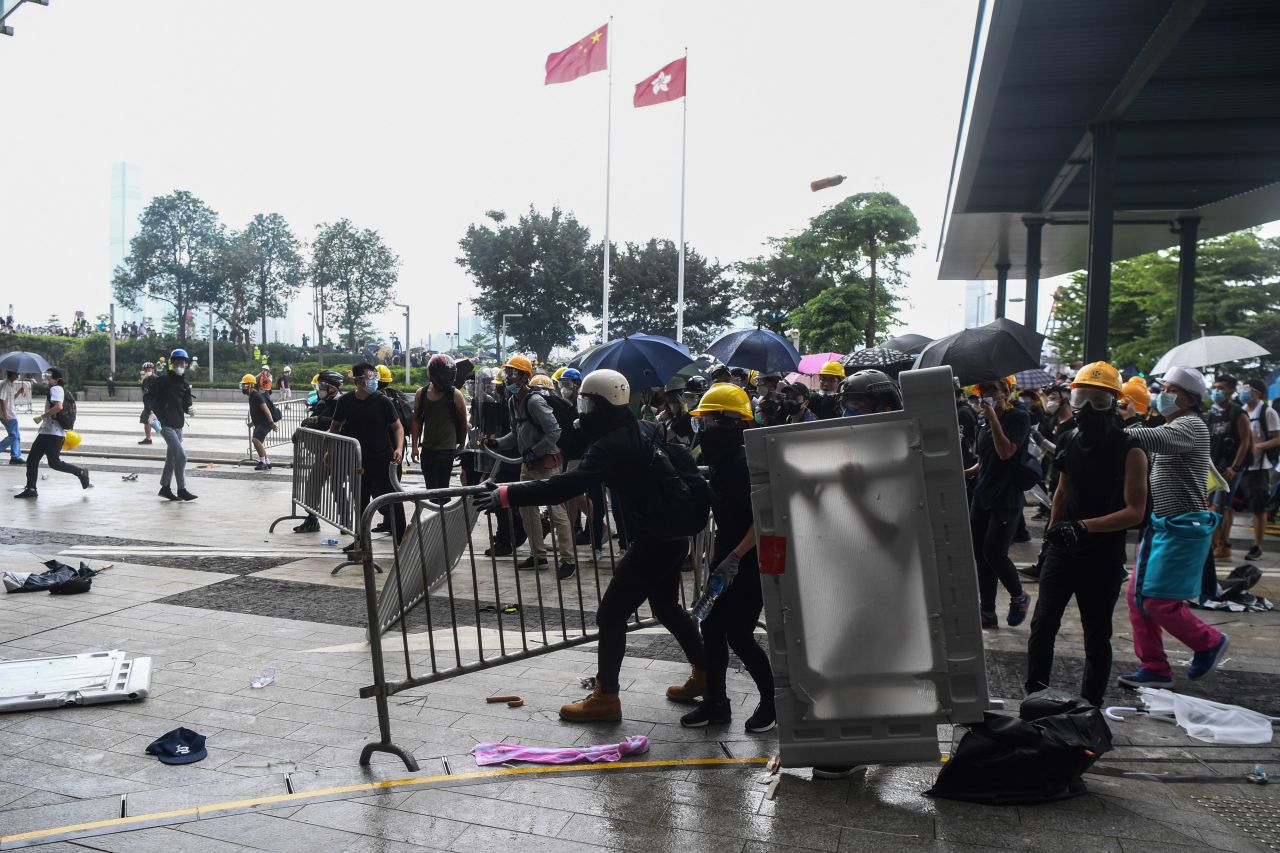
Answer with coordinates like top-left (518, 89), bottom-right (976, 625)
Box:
top-left (925, 688), bottom-right (1111, 806)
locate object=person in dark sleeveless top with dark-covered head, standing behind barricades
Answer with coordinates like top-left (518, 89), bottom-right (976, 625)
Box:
top-left (410, 352), bottom-right (467, 489)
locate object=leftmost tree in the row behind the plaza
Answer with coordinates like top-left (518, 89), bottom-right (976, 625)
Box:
top-left (111, 190), bottom-right (224, 343)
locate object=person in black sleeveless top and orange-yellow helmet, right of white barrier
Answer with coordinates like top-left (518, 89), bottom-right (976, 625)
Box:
top-left (1025, 361), bottom-right (1147, 706)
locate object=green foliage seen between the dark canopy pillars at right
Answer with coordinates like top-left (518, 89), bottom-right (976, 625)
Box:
top-left (1051, 229), bottom-right (1280, 373)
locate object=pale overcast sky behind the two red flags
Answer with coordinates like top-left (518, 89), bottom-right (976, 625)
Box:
top-left (0, 0), bottom-right (988, 339)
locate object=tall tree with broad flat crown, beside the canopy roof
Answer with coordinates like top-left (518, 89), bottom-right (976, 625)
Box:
top-left (809, 192), bottom-right (920, 347)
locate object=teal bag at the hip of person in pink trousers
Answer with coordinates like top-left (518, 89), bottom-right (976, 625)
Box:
top-left (1135, 510), bottom-right (1222, 607)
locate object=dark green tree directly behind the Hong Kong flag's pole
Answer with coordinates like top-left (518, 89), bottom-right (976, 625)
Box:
top-left (609, 240), bottom-right (735, 352)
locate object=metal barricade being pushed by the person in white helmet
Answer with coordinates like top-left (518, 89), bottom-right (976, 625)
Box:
top-left (358, 468), bottom-right (709, 771)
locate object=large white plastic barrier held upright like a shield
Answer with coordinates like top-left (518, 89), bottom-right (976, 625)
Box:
top-left (746, 368), bottom-right (988, 767)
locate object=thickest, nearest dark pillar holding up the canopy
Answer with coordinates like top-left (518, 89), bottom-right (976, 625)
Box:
top-left (1084, 122), bottom-right (1116, 361)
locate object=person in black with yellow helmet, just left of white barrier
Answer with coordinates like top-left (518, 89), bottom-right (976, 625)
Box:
top-left (668, 386), bottom-right (777, 731)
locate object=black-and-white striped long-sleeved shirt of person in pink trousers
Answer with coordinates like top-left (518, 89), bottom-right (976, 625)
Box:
top-left (1126, 412), bottom-right (1211, 517)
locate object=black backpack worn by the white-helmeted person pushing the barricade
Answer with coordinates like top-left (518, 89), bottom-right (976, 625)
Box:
top-left (640, 424), bottom-right (712, 542)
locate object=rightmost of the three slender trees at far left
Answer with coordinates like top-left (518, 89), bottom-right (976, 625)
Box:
top-left (310, 219), bottom-right (399, 351)
